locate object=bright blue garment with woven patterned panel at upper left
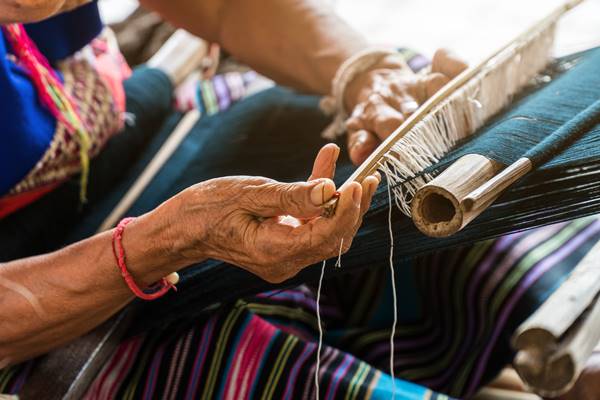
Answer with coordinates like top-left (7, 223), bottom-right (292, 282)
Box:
top-left (0, 3), bottom-right (129, 218)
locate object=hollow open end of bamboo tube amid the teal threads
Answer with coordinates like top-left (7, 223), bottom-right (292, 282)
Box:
top-left (411, 154), bottom-right (503, 237)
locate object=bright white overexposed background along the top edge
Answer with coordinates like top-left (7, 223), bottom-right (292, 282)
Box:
top-left (100, 0), bottom-right (600, 62)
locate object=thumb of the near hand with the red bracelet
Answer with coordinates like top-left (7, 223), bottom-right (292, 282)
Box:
top-left (245, 179), bottom-right (336, 218)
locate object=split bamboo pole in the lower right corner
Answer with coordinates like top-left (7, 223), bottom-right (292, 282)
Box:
top-left (513, 242), bottom-right (600, 397)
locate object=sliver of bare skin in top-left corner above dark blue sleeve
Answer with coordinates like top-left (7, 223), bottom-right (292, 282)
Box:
top-left (0, 0), bottom-right (91, 24)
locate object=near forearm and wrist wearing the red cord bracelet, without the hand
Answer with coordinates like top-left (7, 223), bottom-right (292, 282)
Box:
top-left (0, 205), bottom-right (185, 368)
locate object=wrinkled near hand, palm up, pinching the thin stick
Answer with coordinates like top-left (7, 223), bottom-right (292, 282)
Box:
top-left (166, 144), bottom-right (379, 283)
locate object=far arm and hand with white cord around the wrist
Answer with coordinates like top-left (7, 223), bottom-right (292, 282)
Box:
top-left (142, 0), bottom-right (466, 164)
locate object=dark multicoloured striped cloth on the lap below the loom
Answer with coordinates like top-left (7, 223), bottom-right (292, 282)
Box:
top-left (0, 217), bottom-right (600, 399)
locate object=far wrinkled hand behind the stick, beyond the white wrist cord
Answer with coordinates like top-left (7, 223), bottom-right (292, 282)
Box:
top-left (345, 50), bottom-right (467, 165)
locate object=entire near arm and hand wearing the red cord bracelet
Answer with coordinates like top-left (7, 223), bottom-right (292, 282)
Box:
top-left (0, 145), bottom-right (378, 369)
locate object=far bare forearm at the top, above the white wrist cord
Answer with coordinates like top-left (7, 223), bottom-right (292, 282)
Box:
top-left (144, 0), bottom-right (367, 94)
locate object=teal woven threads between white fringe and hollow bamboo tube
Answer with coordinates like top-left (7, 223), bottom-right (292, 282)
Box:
top-left (426, 49), bottom-right (600, 170)
